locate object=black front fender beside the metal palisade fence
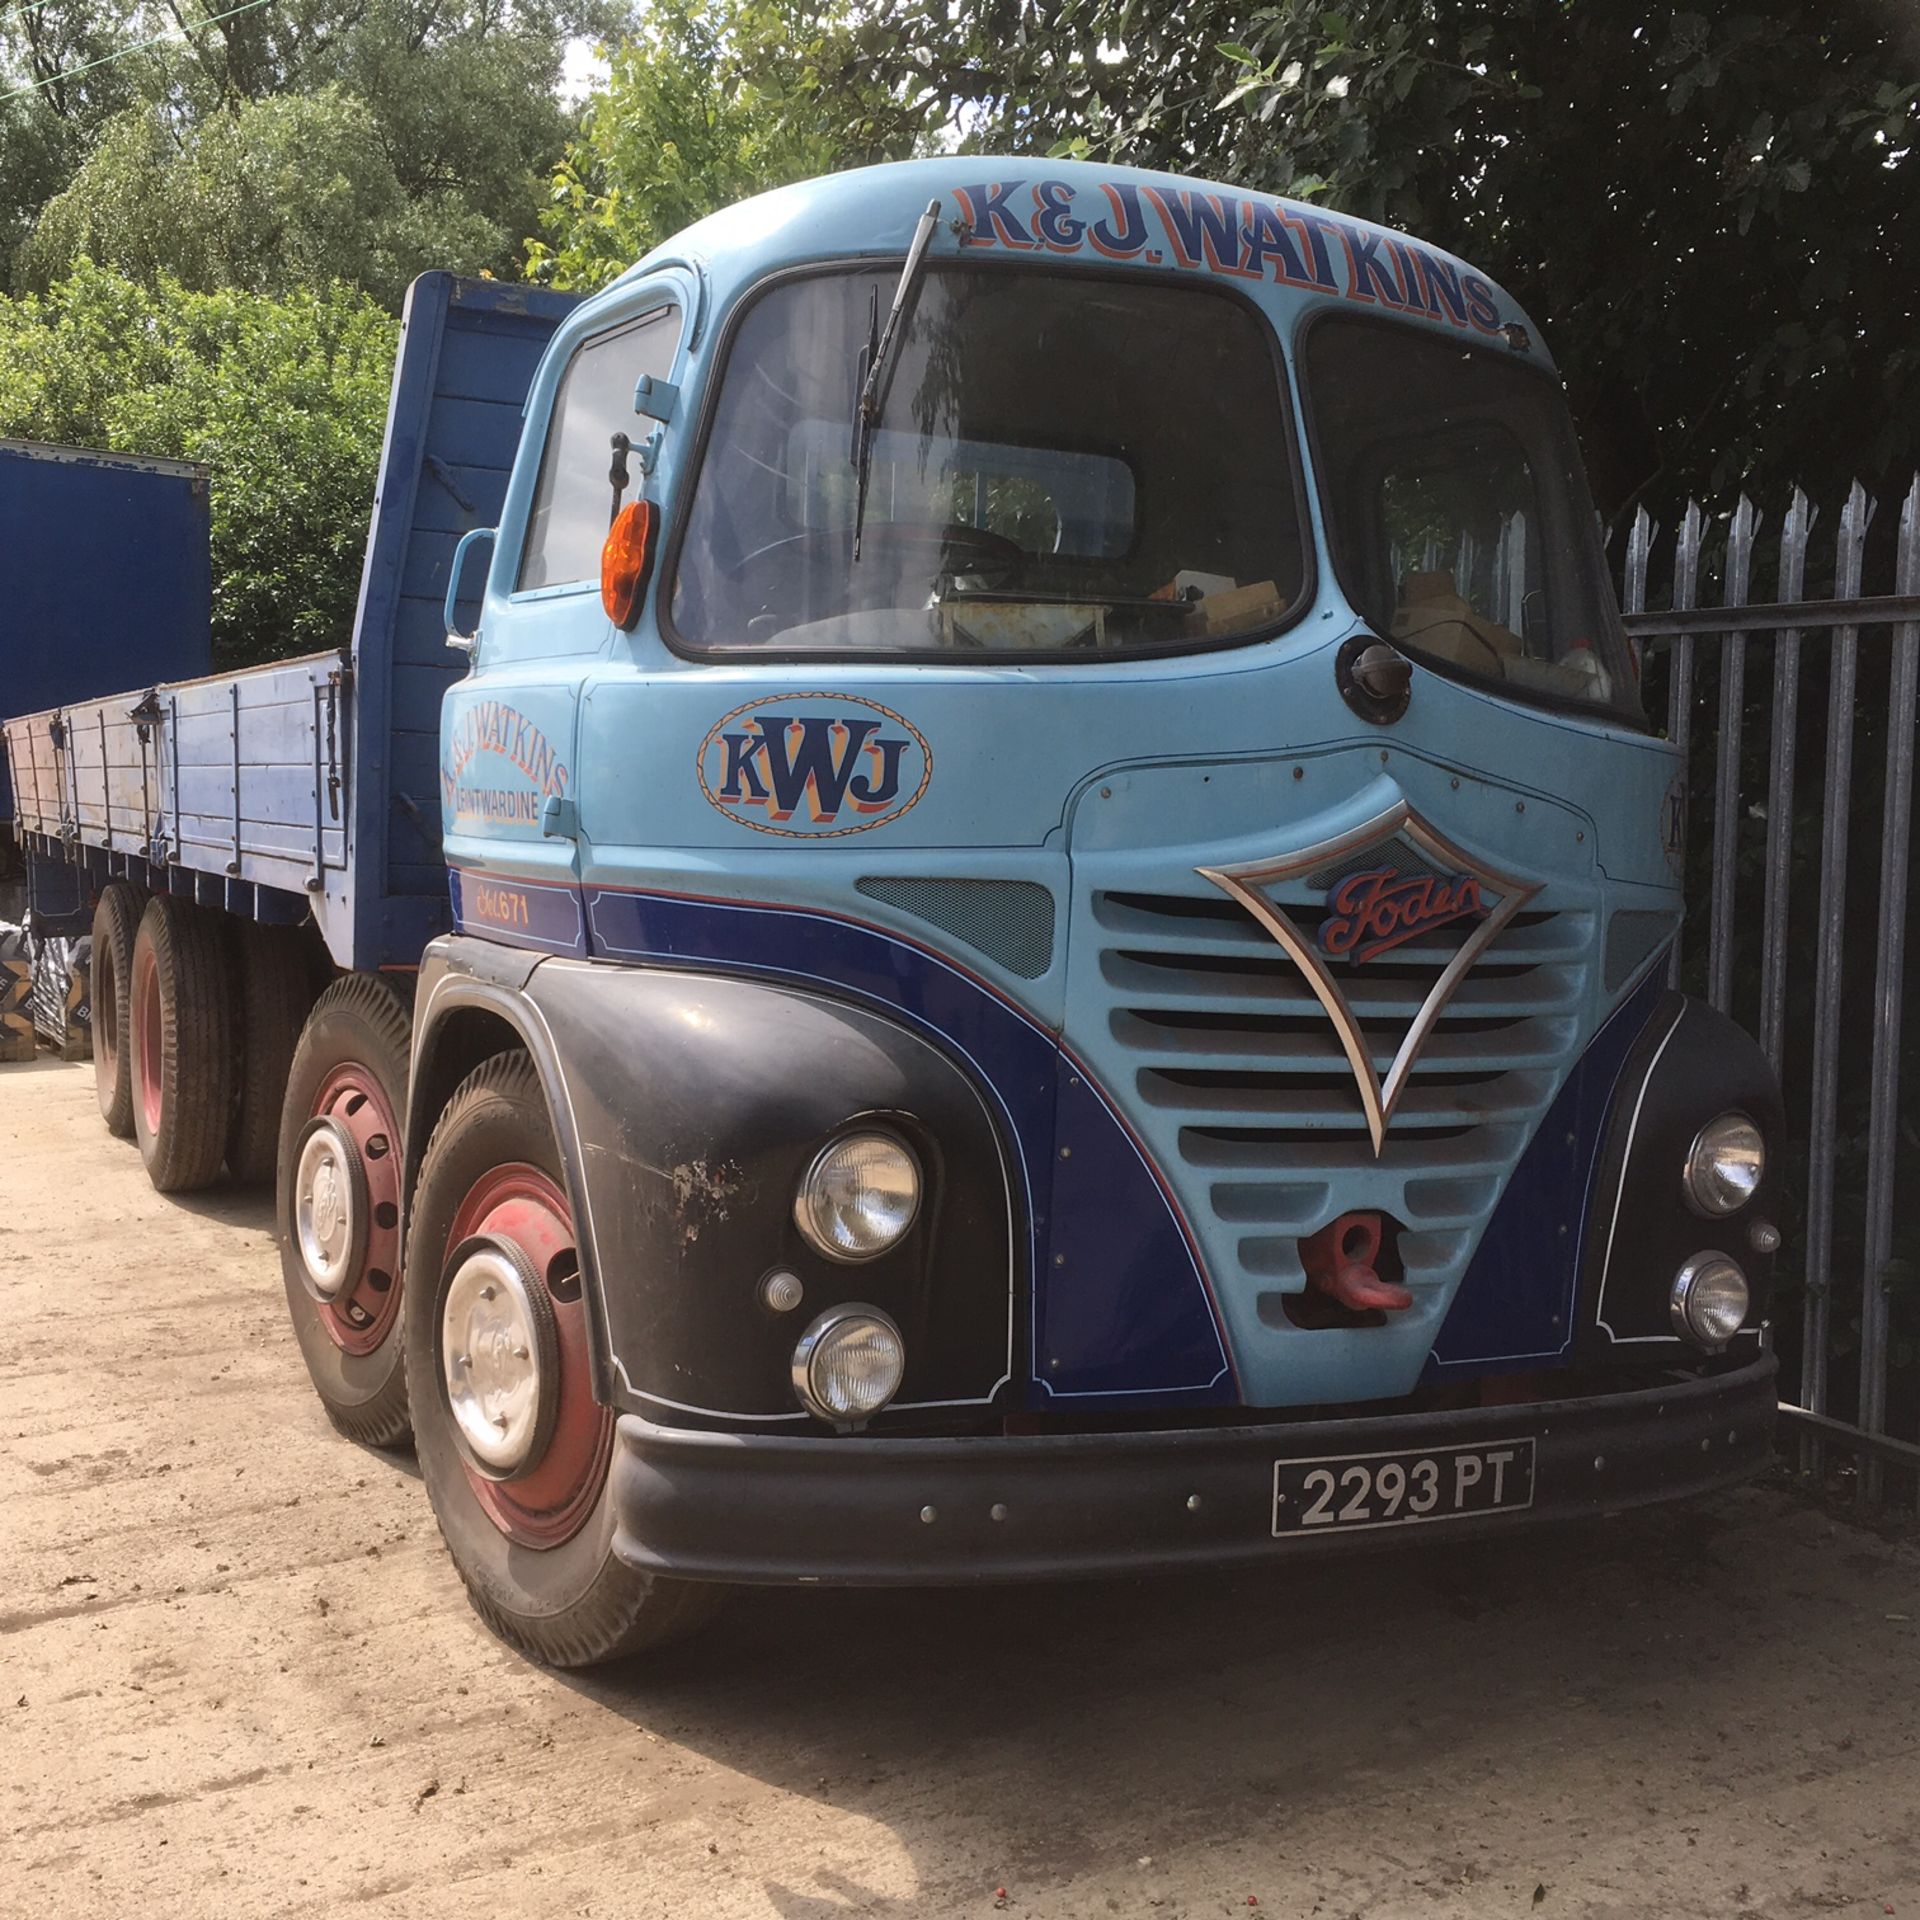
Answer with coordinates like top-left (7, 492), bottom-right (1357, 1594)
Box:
top-left (1580, 991), bottom-right (1786, 1359)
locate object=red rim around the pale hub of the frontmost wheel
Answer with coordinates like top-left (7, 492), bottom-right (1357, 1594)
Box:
top-left (442, 1162), bottom-right (612, 1548)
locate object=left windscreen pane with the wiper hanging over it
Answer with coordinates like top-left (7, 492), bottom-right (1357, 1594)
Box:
top-left (672, 267), bottom-right (1306, 659)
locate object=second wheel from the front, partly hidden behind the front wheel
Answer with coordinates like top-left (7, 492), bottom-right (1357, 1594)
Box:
top-left (275, 973), bottom-right (413, 1446)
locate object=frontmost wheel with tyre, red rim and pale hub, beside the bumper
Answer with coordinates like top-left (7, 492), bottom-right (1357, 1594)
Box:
top-left (405, 1052), bottom-right (720, 1667)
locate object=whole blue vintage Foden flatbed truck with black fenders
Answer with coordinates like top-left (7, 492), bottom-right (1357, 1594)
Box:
top-left (8, 157), bottom-right (1782, 1665)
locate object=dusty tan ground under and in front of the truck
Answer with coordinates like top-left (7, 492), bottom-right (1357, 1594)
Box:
top-left (0, 1064), bottom-right (1920, 1920)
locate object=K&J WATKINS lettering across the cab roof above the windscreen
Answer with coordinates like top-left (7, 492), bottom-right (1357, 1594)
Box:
top-left (954, 180), bottom-right (1500, 334)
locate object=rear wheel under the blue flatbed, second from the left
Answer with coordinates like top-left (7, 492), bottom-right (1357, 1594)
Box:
top-left (127, 893), bottom-right (232, 1194)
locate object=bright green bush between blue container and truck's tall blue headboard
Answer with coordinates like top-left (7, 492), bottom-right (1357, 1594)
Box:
top-left (0, 263), bottom-right (397, 664)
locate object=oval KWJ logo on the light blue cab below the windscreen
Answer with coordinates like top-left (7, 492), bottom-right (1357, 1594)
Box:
top-left (699, 693), bottom-right (933, 839)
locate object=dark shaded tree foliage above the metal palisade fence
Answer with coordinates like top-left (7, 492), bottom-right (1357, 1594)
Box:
top-left (940, 0), bottom-right (1920, 505)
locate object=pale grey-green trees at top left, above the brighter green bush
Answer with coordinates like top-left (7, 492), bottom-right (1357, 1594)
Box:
top-left (0, 0), bottom-right (624, 305)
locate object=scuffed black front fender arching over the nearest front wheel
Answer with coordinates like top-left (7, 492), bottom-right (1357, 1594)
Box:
top-left (409, 937), bottom-right (1018, 1430)
